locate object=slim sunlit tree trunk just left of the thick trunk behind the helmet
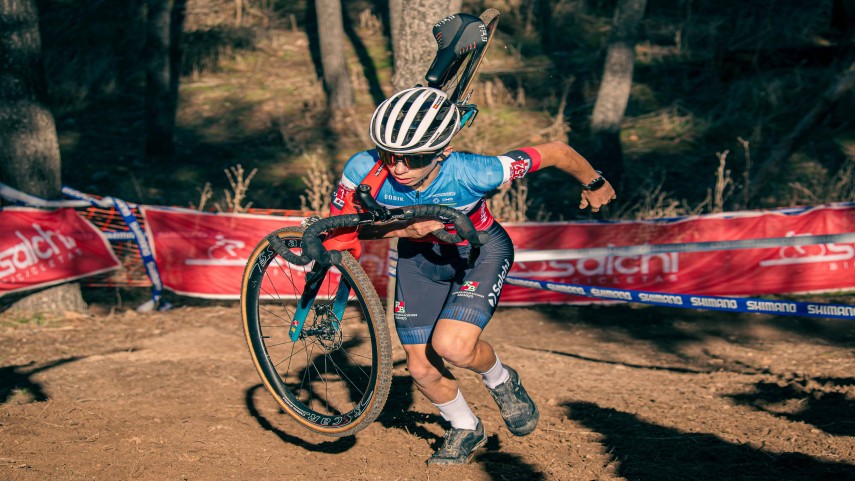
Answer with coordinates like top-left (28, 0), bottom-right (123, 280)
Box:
top-left (315, 0), bottom-right (355, 109)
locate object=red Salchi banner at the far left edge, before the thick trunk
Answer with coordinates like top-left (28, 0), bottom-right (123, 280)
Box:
top-left (0, 207), bottom-right (121, 296)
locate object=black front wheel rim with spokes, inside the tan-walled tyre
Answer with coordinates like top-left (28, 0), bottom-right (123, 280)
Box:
top-left (246, 234), bottom-right (378, 432)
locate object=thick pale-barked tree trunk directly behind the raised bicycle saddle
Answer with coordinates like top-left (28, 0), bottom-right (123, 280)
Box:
top-left (389, 0), bottom-right (464, 91)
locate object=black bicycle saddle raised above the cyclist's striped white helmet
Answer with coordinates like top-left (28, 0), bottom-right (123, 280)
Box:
top-left (425, 13), bottom-right (488, 88)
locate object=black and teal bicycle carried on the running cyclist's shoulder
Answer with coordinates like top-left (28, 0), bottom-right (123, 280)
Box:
top-left (241, 9), bottom-right (499, 437)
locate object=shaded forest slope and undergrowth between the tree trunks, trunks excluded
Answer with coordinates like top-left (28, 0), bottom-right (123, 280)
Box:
top-left (11, 0), bottom-right (855, 220)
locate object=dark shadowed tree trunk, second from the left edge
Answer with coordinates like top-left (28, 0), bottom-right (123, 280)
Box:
top-left (145, 0), bottom-right (187, 157)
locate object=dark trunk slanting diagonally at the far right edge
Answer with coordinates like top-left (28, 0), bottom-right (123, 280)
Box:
top-left (749, 63), bottom-right (855, 198)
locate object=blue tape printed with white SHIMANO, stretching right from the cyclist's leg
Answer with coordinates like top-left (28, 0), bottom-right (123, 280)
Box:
top-left (505, 276), bottom-right (855, 320)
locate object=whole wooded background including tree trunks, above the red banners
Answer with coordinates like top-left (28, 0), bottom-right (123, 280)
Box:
top-left (0, 0), bottom-right (855, 310)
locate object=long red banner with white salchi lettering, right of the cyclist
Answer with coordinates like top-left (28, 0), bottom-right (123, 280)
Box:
top-left (502, 204), bottom-right (855, 305)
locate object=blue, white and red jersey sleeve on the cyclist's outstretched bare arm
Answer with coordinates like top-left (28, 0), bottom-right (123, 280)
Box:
top-left (454, 147), bottom-right (540, 193)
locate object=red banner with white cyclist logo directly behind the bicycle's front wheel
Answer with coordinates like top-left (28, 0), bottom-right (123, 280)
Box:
top-left (142, 206), bottom-right (389, 299)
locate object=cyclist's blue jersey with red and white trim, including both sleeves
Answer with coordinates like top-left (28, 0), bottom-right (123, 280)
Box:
top-left (333, 148), bottom-right (540, 230)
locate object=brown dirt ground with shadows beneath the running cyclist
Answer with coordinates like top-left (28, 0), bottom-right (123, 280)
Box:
top-left (0, 299), bottom-right (855, 481)
